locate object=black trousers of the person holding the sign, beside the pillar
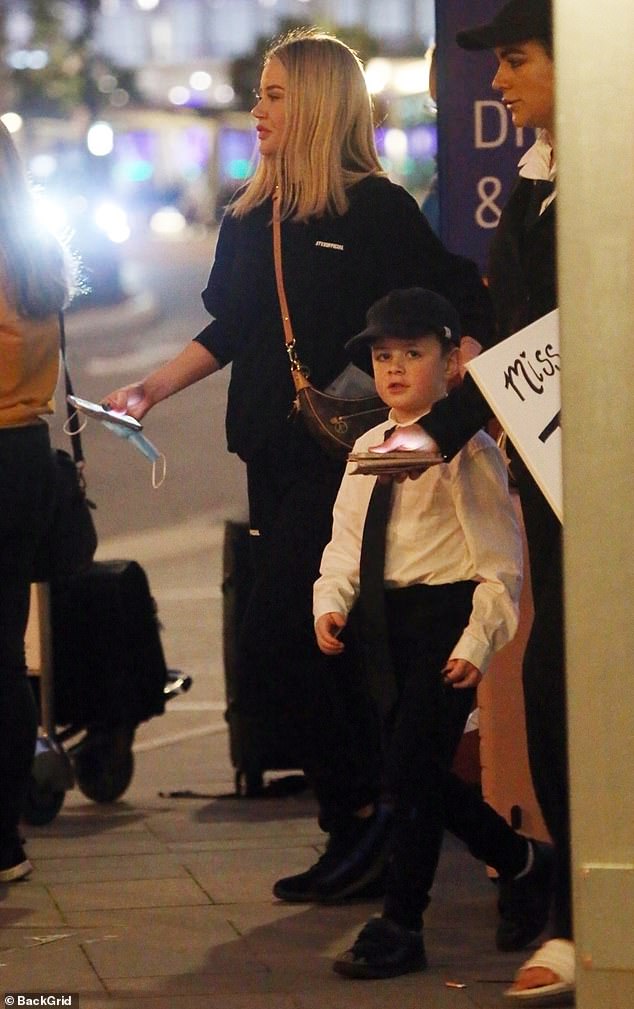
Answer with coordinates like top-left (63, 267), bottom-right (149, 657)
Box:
top-left (511, 452), bottom-right (572, 938)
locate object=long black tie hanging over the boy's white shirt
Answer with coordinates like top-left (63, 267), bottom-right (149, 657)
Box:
top-left (358, 468), bottom-right (398, 719)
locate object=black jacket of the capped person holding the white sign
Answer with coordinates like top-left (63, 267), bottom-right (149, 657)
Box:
top-left (420, 178), bottom-right (557, 458)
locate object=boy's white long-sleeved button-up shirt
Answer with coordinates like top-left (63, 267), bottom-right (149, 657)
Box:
top-left (313, 419), bottom-right (522, 673)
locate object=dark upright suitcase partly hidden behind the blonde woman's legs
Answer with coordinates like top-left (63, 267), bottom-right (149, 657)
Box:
top-left (222, 522), bottom-right (305, 797)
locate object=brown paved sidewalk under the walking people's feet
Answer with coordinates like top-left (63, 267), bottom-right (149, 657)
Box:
top-left (0, 712), bottom-right (545, 1009)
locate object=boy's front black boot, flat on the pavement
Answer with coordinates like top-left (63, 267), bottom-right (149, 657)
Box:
top-left (332, 918), bottom-right (427, 979)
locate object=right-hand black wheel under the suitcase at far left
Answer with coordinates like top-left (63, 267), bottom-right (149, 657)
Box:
top-left (71, 725), bottom-right (134, 802)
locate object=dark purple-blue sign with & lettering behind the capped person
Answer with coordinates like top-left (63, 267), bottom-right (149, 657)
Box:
top-left (436, 0), bottom-right (535, 273)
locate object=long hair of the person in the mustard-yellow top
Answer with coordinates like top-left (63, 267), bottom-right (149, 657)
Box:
top-left (0, 122), bottom-right (73, 319)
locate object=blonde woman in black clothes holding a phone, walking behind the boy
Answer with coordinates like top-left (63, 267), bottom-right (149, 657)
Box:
top-left (107, 30), bottom-right (488, 900)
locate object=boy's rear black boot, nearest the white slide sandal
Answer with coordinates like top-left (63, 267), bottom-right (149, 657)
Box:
top-left (496, 838), bottom-right (553, 952)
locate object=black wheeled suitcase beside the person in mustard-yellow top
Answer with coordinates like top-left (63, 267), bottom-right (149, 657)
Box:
top-left (23, 561), bottom-right (187, 824)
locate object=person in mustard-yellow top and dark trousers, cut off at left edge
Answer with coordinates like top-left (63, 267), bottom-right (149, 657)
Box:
top-left (0, 122), bottom-right (72, 883)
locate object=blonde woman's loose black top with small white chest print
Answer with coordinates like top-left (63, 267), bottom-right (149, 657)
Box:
top-left (196, 176), bottom-right (492, 459)
